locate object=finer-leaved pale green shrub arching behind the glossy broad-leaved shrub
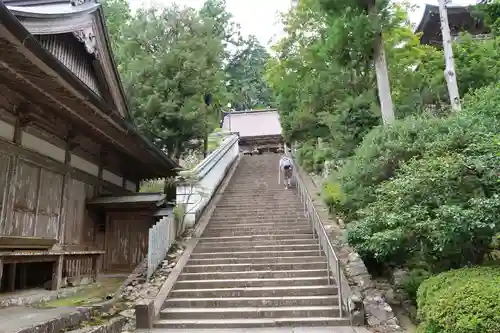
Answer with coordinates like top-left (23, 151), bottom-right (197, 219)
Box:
top-left (329, 118), bottom-right (475, 218)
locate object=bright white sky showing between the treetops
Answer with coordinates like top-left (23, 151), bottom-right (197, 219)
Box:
top-left (128, 0), bottom-right (475, 47)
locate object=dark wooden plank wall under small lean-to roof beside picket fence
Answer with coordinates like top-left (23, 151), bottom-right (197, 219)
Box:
top-left (103, 211), bottom-right (154, 272)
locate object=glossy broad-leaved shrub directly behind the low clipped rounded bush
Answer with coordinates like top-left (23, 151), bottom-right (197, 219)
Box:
top-left (348, 148), bottom-right (500, 271)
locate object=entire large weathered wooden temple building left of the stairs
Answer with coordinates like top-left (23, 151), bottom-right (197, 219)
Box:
top-left (0, 0), bottom-right (176, 291)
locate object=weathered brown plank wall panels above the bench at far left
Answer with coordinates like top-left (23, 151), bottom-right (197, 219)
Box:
top-left (0, 151), bottom-right (94, 245)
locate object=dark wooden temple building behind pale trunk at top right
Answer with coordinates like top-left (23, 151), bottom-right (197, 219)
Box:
top-left (415, 4), bottom-right (489, 48)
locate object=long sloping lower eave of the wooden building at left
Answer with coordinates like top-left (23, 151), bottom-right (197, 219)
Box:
top-left (0, 0), bottom-right (177, 179)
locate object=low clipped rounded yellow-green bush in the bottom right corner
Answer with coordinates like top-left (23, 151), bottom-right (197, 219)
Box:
top-left (417, 267), bottom-right (500, 333)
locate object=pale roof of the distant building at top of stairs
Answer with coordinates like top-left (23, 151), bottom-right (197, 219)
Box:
top-left (222, 109), bottom-right (282, 138)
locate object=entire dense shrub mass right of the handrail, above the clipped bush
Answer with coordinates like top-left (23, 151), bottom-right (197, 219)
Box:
top-left (338, 85), bottom-right (500, 272)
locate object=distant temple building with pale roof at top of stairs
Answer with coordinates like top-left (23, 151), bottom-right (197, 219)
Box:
top-left (221, 109), bottom-right (284, 151)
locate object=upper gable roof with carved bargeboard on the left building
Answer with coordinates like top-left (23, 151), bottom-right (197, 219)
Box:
top-left (3, 0), bottom-right (130, 119)
